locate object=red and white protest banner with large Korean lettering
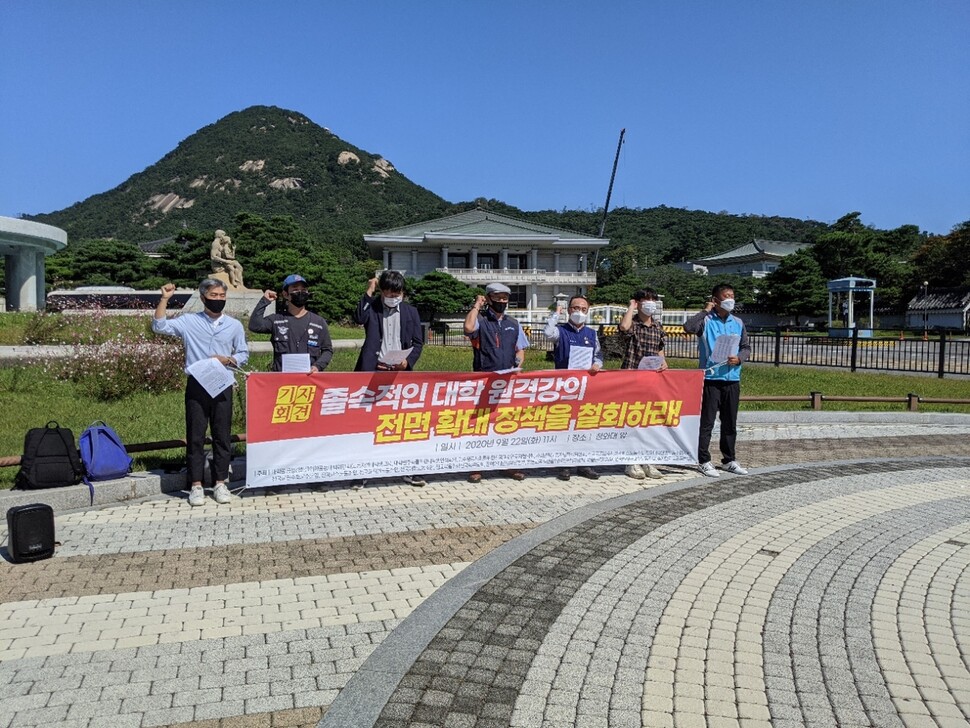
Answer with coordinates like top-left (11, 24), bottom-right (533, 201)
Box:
top-left (246, 370), bottom-right (704, 487)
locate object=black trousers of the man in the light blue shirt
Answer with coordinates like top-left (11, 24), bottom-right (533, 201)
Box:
top-left (185, 377), bottom-right (232, 484)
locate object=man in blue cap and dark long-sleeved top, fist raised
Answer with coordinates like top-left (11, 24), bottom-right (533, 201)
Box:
top-left (249, 273), bottom-right (333, 372)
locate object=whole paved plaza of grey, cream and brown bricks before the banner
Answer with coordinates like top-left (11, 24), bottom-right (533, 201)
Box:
top-left (0, 412), bottom-right (970, 728)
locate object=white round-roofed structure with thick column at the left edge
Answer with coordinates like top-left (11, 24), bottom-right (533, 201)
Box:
top-left (0, 217), bottom-right (67, 311)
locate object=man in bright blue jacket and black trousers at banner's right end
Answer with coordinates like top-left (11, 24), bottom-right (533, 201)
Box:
top-left (684, 283), bottom-right (751, 478)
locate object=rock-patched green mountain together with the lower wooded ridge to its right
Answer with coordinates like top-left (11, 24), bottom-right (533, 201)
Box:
top-left (30, 101), bottom-right (828, 267)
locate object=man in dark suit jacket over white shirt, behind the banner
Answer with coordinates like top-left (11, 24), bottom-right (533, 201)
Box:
top-left (354, 270), bottom-right (426, 487)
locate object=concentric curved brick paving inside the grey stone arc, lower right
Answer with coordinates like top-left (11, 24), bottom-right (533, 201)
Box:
top-left (332, 460), bottom-right (970, 728)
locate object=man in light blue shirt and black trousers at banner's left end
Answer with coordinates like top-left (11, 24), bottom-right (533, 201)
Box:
top-left (152, 278), bottom-right (249, 506)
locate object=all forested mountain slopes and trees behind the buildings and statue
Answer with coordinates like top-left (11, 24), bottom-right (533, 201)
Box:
top-left (15, 106), bottom-right (968, 315)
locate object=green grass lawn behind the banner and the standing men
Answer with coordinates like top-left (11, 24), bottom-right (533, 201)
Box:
top-left (0, 342), bottom-right (970, 488)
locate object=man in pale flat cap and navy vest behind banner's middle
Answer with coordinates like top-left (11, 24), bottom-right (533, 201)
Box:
top-left (465, 283), bottom-right (529, 483)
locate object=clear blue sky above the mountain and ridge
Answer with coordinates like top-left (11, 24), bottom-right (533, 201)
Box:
top-left (0, 0), bottom-right (970, 233)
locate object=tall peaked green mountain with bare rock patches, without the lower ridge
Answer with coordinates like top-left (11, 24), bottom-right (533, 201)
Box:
top-left (30, 106), bottom-right (452, 242)
